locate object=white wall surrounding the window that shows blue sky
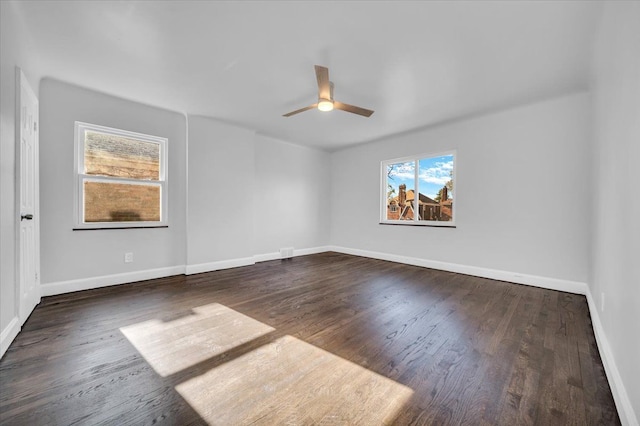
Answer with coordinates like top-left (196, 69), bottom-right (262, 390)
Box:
top-left (331, 94), bottom-right (591, 288)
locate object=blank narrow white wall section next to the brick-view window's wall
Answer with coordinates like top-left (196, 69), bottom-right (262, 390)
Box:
top-left (187, 116), bottom-right (254, 272)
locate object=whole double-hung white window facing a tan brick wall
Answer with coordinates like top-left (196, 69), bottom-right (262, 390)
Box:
top-left (74, 121), bottom-right (167, 229)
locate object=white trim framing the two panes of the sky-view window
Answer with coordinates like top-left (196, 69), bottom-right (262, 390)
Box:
top-left (379, 149), bottom-right (458, 228)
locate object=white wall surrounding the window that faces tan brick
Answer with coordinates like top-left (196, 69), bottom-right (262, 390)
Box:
top-left (40, 79), bottom-right (186, 295)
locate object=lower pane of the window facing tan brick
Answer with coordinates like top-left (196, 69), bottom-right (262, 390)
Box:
top-left (84, 181), bottom-right (160, 222)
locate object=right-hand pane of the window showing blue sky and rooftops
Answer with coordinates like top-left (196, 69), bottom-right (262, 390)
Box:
top-left (418, 155), bottom-right (454, 222)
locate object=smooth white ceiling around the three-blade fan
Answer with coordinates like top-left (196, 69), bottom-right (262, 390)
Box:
top-left (15, 1), bottom-right (601, 150)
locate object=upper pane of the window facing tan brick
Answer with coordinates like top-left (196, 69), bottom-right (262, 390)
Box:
top-left (84, 130), bottom-right (160, 180)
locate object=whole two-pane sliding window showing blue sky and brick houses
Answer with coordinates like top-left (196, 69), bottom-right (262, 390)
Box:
top-left (380, 151), bottom-right (456, 226)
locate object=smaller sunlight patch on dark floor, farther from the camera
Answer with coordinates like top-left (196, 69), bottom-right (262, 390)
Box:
top-left (120, 303), bottom-right (274, 377)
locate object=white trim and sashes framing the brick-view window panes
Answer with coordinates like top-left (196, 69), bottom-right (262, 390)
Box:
top-left (73, 121), bottom-right (169, 230)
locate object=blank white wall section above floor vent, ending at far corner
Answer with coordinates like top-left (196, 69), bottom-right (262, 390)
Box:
top-left (251, 135), bottom-right (331, 255)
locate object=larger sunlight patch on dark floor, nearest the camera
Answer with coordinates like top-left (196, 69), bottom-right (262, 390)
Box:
top-left (176, 336), bottom-right (413, 425)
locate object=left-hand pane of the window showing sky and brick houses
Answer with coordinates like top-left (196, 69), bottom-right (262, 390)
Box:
top-left (387, 161), bottom-right (416, 220)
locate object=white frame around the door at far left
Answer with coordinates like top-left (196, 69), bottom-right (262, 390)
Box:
top-left (15, 67), bottom-right (41, 327)
